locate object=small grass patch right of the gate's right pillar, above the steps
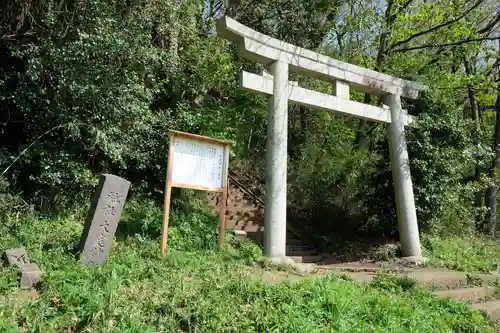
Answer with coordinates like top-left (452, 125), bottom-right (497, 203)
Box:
top-left (422, 236), bottom-right (500, 273)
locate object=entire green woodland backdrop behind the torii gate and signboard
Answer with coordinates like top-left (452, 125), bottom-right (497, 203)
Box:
top-left (0, 0), bottom-right (498, 249)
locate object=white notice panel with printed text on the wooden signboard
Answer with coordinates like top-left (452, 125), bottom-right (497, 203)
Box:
top-left (172, 136), bottom-right (224, 188)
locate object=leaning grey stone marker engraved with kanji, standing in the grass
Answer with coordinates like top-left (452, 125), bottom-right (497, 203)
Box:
top-left (79, 174), bottom-right (130, 266)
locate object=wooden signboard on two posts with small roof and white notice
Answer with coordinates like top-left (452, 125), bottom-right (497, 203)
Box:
top-left (161, 131), bottom-right (231, 256)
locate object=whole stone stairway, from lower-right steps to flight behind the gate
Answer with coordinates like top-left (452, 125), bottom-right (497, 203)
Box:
top-left (208, 175), bottom-right (500, 321)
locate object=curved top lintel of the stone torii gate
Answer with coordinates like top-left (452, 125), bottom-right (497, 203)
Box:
top-left (217, 16), bottom-right (426, 99)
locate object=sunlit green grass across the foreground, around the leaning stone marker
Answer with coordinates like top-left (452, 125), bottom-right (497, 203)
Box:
top-left (0, 198), bottom-right (494, 333)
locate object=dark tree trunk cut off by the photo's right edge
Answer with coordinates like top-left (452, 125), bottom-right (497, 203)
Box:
top-left (483, 91), bottom-right (500, 234)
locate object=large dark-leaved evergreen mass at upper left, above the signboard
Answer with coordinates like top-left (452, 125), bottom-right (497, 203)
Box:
top-left (0, 0), bottom-right (236, 206)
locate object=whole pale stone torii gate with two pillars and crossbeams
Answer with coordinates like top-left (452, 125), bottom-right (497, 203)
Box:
top-left (217, 16), bottom-right (425, 263)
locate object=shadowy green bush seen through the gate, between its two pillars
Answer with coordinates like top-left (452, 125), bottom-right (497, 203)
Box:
top-left (288, 115), bottom-right (372, 233)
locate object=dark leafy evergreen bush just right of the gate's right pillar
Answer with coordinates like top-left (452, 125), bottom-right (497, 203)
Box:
top-left (409, 92), bottom-right (489, 233)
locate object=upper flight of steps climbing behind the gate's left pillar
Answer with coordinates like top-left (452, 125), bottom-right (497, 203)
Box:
top-left (207, 172), bottom-right (322, 263)
